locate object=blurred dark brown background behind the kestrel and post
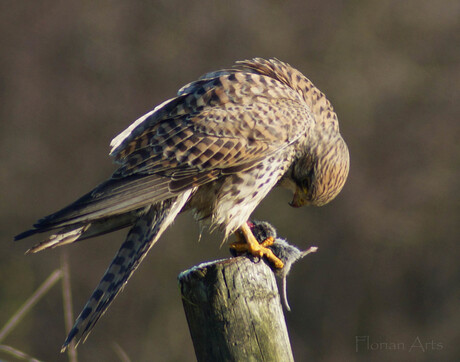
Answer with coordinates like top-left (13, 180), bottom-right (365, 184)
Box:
top-left (0, 0), bottom-right (460, 361)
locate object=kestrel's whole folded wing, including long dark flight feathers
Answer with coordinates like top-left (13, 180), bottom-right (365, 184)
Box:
top-left (16, 60), bottom-right (313, 239)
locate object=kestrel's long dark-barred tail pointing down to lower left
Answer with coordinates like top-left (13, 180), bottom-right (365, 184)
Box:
top-left (61, 190), bottom-right (192, 352)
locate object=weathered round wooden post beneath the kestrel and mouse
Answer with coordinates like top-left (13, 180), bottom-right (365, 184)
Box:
top-left (179, 257), bottom-right (294, 362)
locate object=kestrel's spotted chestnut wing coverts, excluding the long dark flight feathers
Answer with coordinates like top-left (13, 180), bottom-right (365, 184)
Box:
top-left (111, 65), bottom-right (311, 192)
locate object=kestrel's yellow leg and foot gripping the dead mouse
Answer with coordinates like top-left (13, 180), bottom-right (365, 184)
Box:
top-left (230, 223), bottom-right (284, 269)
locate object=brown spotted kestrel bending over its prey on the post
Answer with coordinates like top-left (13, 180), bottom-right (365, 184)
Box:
top-left (16, 58), bottom-right (349, 350)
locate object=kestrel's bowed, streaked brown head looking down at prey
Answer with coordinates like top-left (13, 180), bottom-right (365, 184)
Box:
top-left (290, 136), bottom-right (350, 207)
